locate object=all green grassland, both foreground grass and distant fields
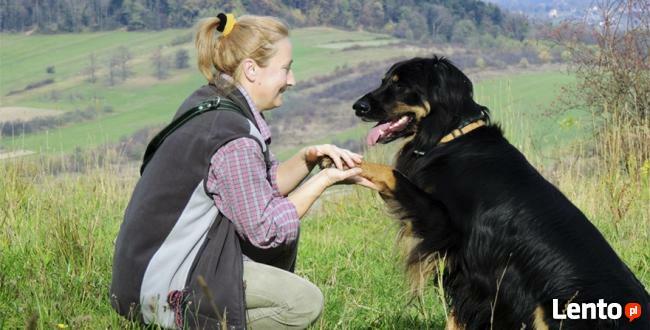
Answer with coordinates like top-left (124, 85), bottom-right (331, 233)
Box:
top-left (0, 28), bottom-right (650, 330)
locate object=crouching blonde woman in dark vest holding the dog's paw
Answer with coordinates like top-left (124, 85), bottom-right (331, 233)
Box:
top-left (111, 14), bottom-right (374, 329)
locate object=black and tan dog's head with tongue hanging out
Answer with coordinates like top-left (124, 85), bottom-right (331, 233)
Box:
top-left (353, 56), bottom-right (487, 145)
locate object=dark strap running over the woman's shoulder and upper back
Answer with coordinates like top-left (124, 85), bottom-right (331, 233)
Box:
top-left (140, 96), bottom-right (243, 175)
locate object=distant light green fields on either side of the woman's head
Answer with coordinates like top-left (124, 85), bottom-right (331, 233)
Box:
top-left (0, 28), bottom-right (420, 153)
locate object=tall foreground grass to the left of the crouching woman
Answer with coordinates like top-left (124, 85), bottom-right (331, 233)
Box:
top-left (0, 162), bottom-right (131, 329)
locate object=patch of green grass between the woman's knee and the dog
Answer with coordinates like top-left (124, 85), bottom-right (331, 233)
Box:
top-left (299, 190), bottom-right (445, 329)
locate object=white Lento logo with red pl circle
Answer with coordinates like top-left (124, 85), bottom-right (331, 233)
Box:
top-left (553, 299), bottom-right (643, 322)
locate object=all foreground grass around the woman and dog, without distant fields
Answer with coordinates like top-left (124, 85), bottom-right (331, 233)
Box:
top-left (0, 101), bottom-right (650, 329)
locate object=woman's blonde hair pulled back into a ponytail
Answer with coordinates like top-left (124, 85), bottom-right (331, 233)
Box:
top-left (194, 15), bottom-right (289, 82)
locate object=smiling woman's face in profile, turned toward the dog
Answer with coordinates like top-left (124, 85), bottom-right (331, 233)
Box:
top-left (244, 38), bottom-right (296, 111)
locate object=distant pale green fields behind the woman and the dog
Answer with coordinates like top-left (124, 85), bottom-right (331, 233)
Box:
top-left (0, 28), bottom-right (576, 164)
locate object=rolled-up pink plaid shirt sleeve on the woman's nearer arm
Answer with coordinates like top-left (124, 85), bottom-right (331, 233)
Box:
top-left (206, 138), bottom-right (300, 248)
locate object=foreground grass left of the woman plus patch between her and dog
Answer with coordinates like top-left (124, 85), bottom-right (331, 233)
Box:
top-left (0, 151), bottom-right (444, 329)
